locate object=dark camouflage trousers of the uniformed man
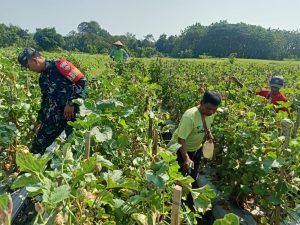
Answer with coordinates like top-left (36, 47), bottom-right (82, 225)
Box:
top-left (30, 117), bottom-right (75, 154)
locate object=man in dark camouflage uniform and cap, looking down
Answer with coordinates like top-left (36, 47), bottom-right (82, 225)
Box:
top-left (18, 47), bottom-right (86, 154)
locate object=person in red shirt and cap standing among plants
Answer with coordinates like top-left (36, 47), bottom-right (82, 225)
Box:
top-left (230, 76), bottom-right (288, 112)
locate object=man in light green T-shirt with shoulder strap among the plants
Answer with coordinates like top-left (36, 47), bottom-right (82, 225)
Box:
top-left (168, 91), bottom-right (221, 209)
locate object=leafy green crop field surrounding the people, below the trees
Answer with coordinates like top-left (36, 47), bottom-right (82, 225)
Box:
top-left (0, 48), bottom-right (300, 225)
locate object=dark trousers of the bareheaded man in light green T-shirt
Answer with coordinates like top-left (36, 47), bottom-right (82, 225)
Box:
top-left (177, 149), bottom-right (202, 211)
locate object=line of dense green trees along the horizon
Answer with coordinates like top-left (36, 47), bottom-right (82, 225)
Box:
top-left (0, 21), bottom-right (300, 60)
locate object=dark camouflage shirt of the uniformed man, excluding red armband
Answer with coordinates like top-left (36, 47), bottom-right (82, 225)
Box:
top-left (37, 59), bottom-right (86, 122)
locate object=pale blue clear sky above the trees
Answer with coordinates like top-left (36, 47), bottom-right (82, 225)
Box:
top-left (0, 0), bottom-right (300, 39)
